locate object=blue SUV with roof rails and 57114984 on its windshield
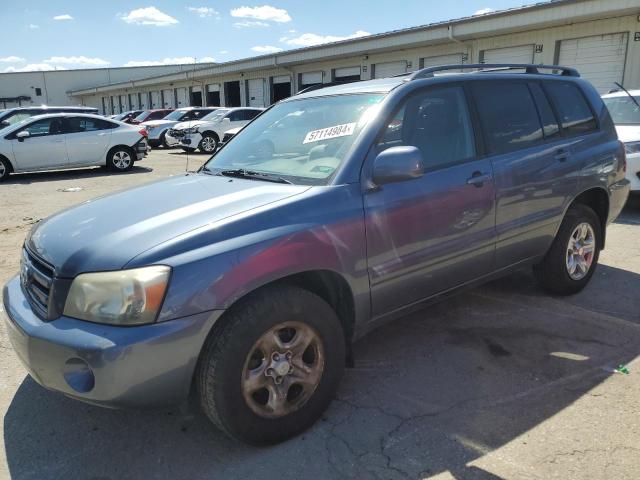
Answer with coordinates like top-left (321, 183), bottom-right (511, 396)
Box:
top-left (4, 65), bottom-right (629, 444)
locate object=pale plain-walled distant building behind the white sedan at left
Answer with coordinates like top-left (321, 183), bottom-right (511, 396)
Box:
top-left (0, 65), bottom-right (215, 108)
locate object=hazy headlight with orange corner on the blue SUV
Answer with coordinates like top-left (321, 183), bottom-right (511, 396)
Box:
top-left (64, 265), bottom-right (171, 325)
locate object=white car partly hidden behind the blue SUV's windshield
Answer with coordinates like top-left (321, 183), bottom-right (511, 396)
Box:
top-left (167, 107), bottom-right (264, 153)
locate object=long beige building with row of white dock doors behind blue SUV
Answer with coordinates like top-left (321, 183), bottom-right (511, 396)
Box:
top-left (0, 0), bottom-right (640, 113)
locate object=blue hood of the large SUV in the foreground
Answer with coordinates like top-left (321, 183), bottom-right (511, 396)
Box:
top-left (27, 174), bottom-right (309, 278)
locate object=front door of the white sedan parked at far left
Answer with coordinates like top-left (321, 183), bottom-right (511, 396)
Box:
top-left (10, 117), bottom-right (69, 170)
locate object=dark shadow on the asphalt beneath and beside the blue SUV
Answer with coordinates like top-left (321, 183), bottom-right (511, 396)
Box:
top-left (4, 265), bottom-right (640, 480)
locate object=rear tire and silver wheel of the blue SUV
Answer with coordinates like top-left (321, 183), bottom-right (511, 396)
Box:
top-left (534, 204), bottom-right (603, 295)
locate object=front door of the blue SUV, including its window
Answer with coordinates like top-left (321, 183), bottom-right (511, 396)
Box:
top-left (364, 86), bottom-right (495, 315)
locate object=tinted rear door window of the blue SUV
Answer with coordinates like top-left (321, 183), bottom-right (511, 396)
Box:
top-left (471, 82), bottom-right (543, 154)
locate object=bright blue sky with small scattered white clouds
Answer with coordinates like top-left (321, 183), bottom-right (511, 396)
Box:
top-left (0, 0), bottom-right (535, 72)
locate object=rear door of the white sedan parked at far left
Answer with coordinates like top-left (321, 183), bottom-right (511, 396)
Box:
top-left (64, 116), bottom-right (118, 165)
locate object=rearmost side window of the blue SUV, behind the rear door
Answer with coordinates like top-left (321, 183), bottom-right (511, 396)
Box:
top-left (544, 82), bottom-right (597, 135)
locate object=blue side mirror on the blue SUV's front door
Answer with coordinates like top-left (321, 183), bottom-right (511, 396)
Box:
top-left (373, 146), bottom-right (424, 185)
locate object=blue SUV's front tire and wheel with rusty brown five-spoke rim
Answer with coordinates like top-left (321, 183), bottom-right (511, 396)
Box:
top-left (196, 285), bottom-right (345, 445)
